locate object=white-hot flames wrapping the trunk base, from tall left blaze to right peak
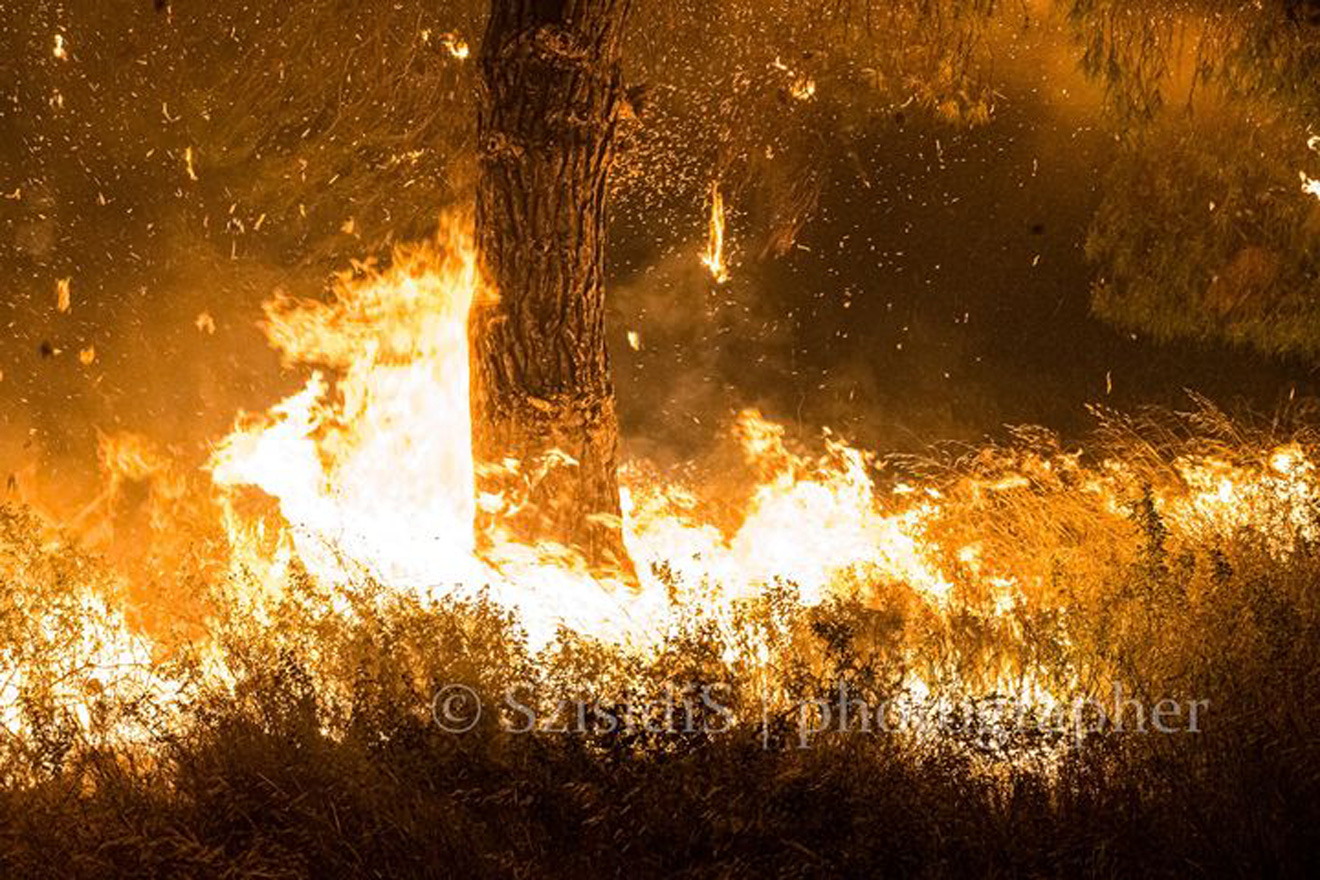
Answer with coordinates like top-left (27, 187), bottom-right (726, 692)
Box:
top-left (211, 215), bottom-right (949, 641)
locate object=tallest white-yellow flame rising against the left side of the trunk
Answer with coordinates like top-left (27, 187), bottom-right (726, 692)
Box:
top-left (213, 215), bottom-right (475, 584)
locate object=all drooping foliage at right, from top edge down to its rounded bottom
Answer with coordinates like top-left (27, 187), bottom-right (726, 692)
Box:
top-left (1069, 0), bottom-right (1320, 356)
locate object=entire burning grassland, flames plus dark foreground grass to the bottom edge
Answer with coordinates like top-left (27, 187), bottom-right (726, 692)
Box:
top-left (0, 224), bottom-right (1320, 876)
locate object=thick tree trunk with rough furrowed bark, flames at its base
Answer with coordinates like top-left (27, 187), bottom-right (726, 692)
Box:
top-left (470, 0), bottom-right (631, 569)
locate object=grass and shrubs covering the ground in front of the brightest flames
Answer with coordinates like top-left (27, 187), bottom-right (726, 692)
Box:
top-left (0, 408), bottom-right (1320, 877)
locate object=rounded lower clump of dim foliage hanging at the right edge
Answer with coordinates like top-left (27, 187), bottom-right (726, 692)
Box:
top-left (1086, 110), bottom-right (1320, 356)
